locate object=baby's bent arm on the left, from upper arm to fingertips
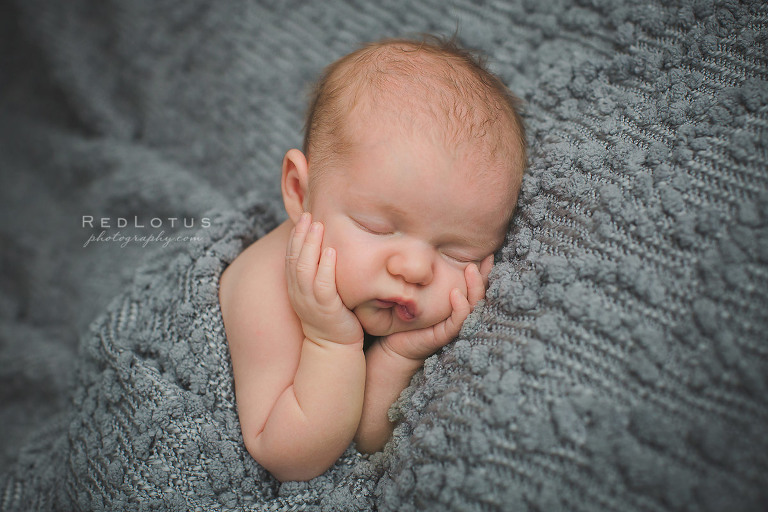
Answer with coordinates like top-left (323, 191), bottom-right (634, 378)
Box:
top-left (222, 217), bottom-right (365, 481)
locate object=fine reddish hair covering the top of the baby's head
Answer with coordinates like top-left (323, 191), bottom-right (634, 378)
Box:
top-left (303, 37), bottom-right (526, 199)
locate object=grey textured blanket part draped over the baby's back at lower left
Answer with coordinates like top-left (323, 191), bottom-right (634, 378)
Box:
top-left (4, 205), bottom-right (380, 510)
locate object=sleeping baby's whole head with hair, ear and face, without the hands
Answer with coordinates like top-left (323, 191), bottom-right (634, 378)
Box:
top-left (282, 39), bottom-right (526, 336)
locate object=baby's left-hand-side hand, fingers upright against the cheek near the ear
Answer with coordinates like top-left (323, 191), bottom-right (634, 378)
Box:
top-left (285, 213), bottom-right (363, 344)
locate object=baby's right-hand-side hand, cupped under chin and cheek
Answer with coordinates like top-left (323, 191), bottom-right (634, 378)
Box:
top-left (381, 255), bottom-right (493, 361)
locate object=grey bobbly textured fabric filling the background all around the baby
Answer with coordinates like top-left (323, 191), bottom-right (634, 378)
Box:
top-left (0, 0), bottom-right (768, 511)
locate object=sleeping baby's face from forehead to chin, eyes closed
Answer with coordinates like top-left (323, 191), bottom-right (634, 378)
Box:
top-left (308, 120), bottom-right (517, 336)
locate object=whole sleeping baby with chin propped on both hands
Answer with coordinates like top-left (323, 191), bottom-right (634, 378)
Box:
top-left (219, 35), bottom-right (526, 481)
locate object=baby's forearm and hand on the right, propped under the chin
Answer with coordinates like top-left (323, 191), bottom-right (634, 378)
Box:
top-left (355, 256), bottom-right (493, 453)
